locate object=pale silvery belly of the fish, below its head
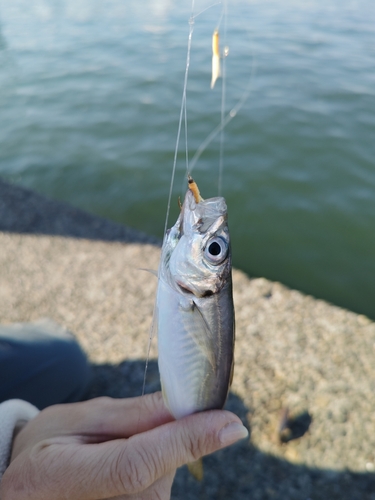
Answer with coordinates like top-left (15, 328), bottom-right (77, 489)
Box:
top-left (157, 282), bottom-right (233, 419)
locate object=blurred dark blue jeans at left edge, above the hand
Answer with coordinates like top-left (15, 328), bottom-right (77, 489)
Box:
top-left (0, 320), bottom-right (91, 409)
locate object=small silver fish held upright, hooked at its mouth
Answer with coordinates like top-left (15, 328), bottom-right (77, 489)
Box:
top-left (154, 177), bottom-right (234, 419)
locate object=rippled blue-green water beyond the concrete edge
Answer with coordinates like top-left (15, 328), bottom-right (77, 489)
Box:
top-left (0, 0), bottom-right (375, 318)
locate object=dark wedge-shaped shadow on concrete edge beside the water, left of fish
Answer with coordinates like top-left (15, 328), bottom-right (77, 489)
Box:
top-left (0, 179), bottom-right (160, 245)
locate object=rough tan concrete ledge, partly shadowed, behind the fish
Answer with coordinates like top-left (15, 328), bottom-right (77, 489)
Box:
top-left (0, 181), bottom-right (375, 500)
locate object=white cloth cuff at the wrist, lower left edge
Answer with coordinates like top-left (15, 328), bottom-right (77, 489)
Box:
top-left (0, 399), bottom-right (39, 481)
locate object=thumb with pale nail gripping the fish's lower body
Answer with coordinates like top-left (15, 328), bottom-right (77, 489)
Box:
top-left (109, 410), bottom-right (249, 494)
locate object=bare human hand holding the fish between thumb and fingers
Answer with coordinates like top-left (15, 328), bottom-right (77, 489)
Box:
top-left (0, 393), bottom-right (247, 500)
